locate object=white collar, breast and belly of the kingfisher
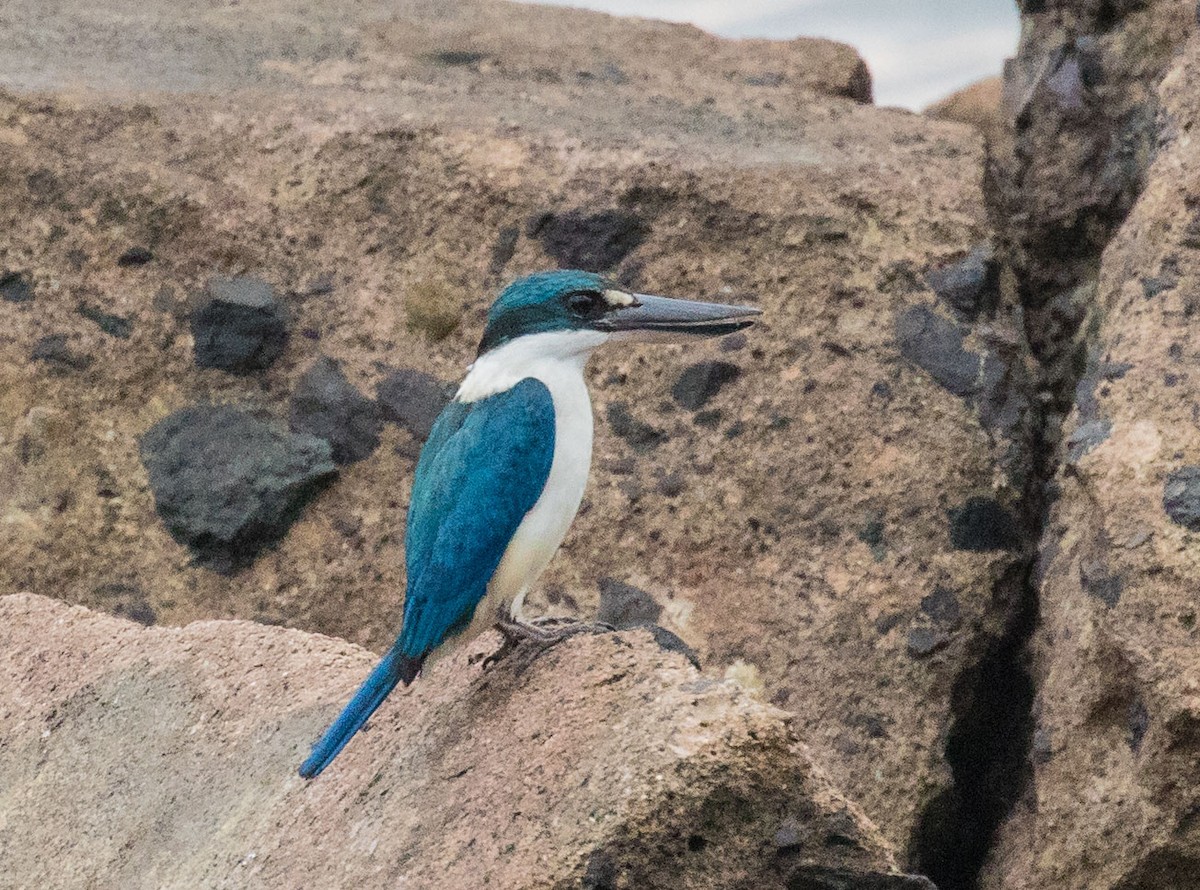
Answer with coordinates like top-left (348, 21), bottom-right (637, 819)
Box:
top-left (455, 331), bottom-right (607, 636)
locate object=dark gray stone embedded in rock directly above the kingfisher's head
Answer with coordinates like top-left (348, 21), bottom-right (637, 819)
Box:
top-left (526, 210), bottom-right (650, 272)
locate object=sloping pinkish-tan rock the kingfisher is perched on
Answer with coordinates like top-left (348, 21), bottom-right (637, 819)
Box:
top-left (0, 594), bottom-right (916, 890)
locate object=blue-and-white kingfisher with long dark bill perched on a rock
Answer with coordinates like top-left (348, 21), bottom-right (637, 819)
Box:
top-left (300, 270), bottom-right (760, 778)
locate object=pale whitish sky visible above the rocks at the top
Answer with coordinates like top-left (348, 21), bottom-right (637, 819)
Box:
top-left (527, 0), bottom-right (1018, 110)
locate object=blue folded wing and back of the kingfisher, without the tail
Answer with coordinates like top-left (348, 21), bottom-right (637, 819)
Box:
top-left (397, 378), bottom-right (554, 659)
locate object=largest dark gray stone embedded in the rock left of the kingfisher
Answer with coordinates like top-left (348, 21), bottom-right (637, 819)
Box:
top-left (140, 405), bottom-right (337, 572)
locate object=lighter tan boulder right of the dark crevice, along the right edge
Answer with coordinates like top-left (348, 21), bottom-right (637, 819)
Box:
top-left (983, 27), bottom-right (1200, 890)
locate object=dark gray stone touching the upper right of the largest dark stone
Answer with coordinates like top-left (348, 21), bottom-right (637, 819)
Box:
top-left (288, 355), bottom-right (383, 465)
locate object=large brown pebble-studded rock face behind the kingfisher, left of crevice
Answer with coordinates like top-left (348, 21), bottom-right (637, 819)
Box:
top-left (0, 0), bottom-right (1028, 885)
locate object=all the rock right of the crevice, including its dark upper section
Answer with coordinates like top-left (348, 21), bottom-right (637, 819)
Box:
top-left (980, 15), bottom-right (1200, 890)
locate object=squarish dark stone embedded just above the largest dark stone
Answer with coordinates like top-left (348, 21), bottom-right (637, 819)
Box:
top-left (192, 276), bottom-right (288, 374)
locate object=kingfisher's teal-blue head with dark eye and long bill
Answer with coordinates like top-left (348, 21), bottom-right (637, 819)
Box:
top-left (479, 270), bottom-right (760, 355)
